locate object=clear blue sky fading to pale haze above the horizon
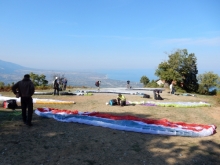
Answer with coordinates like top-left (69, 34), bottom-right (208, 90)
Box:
top-left (0, 0), bottom-right (220, 73)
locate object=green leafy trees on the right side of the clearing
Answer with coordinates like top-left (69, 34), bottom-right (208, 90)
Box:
top-left (140, 49), bottom-right (220, 94)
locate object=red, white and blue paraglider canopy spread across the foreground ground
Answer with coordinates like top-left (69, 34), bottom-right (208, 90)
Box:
top-left (35, 108), bottom-right (216, 137)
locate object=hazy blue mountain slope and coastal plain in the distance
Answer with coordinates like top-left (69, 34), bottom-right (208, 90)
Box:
top-left (0, 60), bottom-right (143, 87)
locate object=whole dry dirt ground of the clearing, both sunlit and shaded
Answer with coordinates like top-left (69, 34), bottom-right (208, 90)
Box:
top-left (0, 91), bottom-right (220, 165)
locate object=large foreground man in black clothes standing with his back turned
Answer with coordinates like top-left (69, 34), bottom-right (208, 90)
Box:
top-left (12, 74), bottom-right (35, 126)
